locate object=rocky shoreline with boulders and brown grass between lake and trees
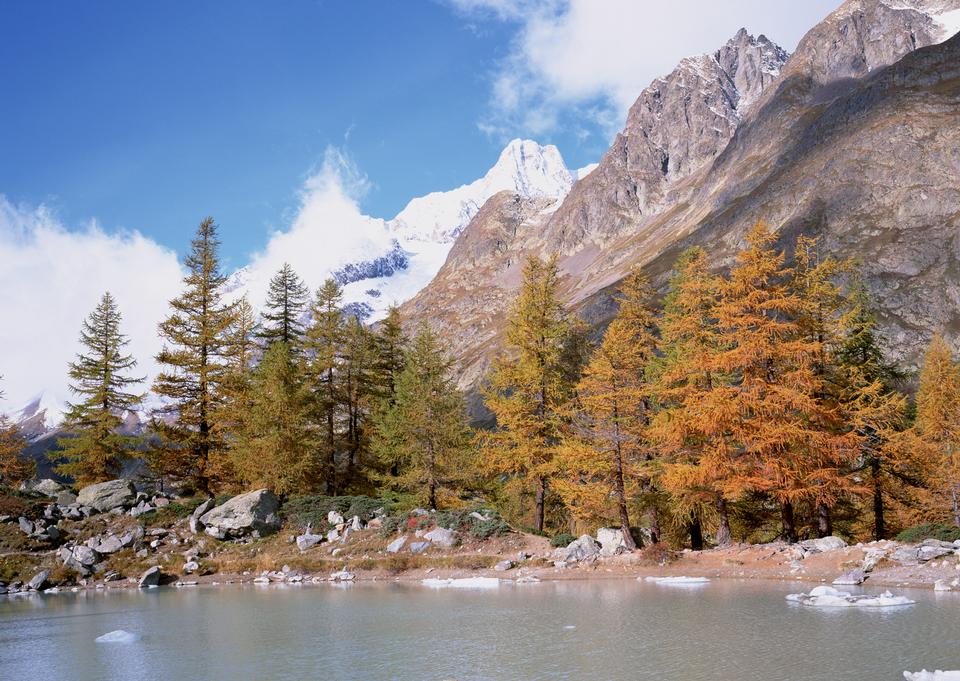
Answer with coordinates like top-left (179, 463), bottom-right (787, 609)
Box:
top-left (0, 480), bottom-right (960, 595)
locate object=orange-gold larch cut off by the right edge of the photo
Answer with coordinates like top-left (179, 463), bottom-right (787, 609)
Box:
top-left (915, 334), bottom-right (960, 527)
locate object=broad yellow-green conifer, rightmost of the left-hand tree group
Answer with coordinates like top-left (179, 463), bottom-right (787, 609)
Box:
top-left (372, 323), bottom-right (470, 508)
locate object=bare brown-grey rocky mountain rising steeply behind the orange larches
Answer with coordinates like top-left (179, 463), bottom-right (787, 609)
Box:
top-left (404, 0), bottom-right (960, 404)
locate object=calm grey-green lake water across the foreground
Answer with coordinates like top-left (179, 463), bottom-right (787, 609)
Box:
top-left (0, 579), bottom-right (960, 681)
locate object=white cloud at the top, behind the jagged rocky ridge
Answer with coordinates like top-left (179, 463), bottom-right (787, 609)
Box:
top-left (447, 0), bottom-right (837, 137)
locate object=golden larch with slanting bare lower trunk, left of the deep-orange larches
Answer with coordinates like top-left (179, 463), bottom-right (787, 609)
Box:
top-left (555, 270), bottom-right (656, 550)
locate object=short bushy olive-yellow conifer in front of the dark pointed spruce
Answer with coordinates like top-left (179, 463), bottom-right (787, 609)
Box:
top-left (230, 340), bottom-right (318, 496)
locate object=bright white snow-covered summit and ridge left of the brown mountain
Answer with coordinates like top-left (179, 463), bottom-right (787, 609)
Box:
top-left (390, 139), bottom-right (575, 243)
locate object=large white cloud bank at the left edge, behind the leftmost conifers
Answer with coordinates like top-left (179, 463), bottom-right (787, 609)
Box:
top-left (0, 195), bottom-right (182, 412)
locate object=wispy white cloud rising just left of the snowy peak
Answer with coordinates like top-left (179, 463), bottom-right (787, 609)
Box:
top-left (243, 147), bottom-right (392, 307)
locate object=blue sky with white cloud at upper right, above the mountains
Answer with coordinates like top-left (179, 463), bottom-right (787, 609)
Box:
top-left (0, 0), bottom-right (833, 266)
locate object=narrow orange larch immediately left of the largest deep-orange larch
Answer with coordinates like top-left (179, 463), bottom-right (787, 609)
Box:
top-left (650, 248), bottom-right (732, 549)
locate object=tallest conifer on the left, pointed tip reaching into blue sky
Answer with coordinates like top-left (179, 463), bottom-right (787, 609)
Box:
top-left (150, 218), bottom-right (234, 495)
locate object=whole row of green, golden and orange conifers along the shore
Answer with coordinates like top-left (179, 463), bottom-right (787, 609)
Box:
top-left (0, 218), bottom-right (960, 549)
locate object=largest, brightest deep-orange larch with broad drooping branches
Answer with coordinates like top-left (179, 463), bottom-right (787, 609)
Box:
top-left (703, 223), bottom-right (855, 542)
